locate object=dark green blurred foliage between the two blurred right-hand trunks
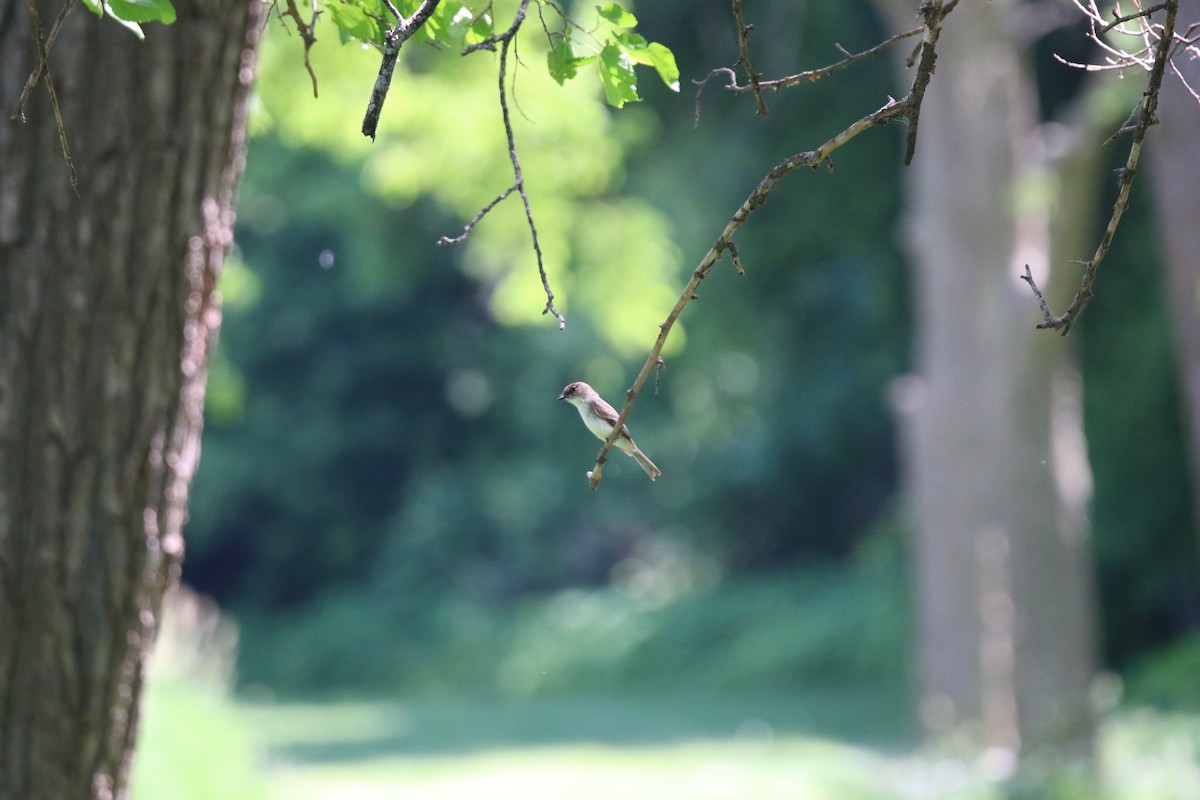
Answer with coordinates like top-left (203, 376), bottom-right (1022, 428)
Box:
top-left (1079, 176), bottom-right (1200, 668)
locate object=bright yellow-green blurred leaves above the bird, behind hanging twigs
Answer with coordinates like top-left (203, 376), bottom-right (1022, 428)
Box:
top-left (250, 10), bottom-right (682, 354)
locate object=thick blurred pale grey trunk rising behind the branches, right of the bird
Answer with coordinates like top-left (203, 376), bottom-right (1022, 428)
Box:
top-left (887, 0), bottom-right (1096, 768)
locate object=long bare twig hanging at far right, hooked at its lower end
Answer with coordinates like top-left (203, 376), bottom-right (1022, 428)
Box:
top-left (1021, 0), bottom-right (1180, 336)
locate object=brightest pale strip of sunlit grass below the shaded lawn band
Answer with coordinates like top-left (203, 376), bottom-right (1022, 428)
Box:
top-left (265, 739), bottom-right (889, 800)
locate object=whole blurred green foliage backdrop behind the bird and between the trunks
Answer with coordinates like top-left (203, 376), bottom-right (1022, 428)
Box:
top-left (184, 0), bottom-right (1200, 724)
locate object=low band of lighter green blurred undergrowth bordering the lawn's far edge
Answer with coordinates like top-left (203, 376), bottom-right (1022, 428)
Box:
top-left (234, 532), bottom-right (910, 705)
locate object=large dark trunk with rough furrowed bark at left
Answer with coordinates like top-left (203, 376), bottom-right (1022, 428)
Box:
top-left (0, 0), bottom-right (258, 800)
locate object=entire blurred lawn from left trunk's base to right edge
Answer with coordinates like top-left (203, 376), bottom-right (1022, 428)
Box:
top-left (133, 685), bottom-right (1200, 800)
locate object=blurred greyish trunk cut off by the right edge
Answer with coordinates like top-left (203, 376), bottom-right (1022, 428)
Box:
top-left (1147, 0), bottom-right (1200, 546)
